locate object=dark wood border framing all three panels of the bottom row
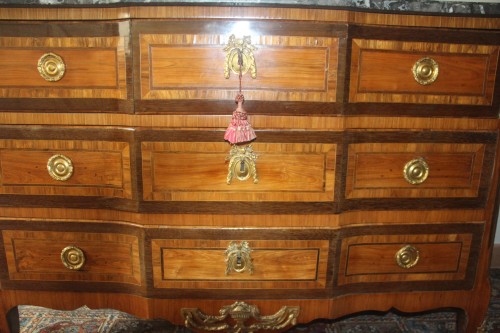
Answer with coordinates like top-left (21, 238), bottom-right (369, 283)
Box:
top-left (0, 221), bottom-right (484, 299)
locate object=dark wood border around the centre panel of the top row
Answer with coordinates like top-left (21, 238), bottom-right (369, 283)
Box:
top-left (132, 19), bottom-right (347, 116)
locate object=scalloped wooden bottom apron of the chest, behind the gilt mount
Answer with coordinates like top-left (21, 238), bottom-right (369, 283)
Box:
top-left (2, 283), bottom-right (490, 332)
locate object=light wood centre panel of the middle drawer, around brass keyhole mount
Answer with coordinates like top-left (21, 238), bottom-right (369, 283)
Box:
top-left (142, 142), bottom-right (336, 201)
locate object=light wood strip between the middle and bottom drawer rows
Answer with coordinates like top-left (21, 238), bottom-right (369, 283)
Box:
top-left (0, 207), bottom-right (486, 228)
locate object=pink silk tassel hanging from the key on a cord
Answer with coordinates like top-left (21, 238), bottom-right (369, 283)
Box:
top-left (224, 94), bottom-right (257, 144)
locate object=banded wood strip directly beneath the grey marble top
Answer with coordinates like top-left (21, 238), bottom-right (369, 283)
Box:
top-left (0, 5), bottom-right (500, 29)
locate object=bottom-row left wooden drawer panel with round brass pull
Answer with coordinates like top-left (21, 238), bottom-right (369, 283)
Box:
top-left (2, 230), bottom-right (142, 285)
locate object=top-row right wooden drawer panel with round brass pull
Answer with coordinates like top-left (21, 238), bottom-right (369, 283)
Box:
top-left (349, 39), bottom-right (499, 105)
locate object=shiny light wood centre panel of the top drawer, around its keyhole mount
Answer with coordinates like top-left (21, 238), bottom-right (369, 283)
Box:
top-left (137, 34), bottom-right (338, 102)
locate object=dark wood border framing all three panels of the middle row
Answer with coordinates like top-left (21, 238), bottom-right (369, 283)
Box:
top-left (0, 126), bottom-right (497, 214)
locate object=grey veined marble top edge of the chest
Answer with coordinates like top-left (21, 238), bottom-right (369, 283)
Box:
top-left (0, 0), bottom-right (500, 15)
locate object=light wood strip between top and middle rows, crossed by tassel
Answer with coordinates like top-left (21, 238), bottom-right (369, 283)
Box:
top-left (0, 112), bottom-right (498, 132)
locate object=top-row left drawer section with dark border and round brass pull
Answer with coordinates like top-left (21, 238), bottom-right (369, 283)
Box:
top-left (0, 23), bottom-right (131, 112)
